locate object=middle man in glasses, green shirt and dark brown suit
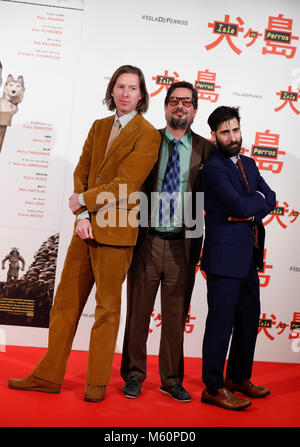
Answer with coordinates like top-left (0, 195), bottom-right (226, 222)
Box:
top-left (121, 82), bottom-right (215, 402)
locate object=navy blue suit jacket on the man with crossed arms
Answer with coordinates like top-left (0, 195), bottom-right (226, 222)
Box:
top-left (201, 150), bottom-right (276, 278)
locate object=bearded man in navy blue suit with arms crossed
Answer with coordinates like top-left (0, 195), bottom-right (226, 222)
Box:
top-left (201, 106), bottom-right (276, 410)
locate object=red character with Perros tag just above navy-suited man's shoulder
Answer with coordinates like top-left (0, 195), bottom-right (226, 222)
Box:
top-left (242, 129), bottom-right (285, 174)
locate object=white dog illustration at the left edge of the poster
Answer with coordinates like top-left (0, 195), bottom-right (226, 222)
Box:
top-left (0, 74), bottom-right (25, 115)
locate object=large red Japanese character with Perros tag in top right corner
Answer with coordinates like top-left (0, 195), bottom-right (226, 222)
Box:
top-left (262, 14), bottom-right (299, 59)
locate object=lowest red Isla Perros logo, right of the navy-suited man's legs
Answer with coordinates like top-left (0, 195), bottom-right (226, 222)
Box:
top-left (258, 312), bottom-right (300, 341)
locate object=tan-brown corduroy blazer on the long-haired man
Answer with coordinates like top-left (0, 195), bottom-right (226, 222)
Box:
top-left (74, 113), bottom-right (160, 246)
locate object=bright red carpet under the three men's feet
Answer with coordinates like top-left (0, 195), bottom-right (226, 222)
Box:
top-left (0, 346), bottom-right (300, 427)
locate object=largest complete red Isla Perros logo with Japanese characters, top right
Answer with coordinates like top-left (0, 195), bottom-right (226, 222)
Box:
top-left (205, 14), bottom-right (299, 59)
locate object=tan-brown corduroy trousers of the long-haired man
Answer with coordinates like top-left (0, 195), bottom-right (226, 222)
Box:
top-left (33, 236), bottom-right (133, 386)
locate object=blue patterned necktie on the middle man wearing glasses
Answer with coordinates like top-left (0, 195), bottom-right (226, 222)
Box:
top-left (159, 138), bottom-right (181, 227)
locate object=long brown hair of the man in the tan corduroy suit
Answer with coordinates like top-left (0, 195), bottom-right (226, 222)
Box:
top-left (103, 65), bottom-right (149, 113)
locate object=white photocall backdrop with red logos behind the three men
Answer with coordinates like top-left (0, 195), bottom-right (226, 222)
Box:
top-left (0, 0), bottom-right (300, 363)
